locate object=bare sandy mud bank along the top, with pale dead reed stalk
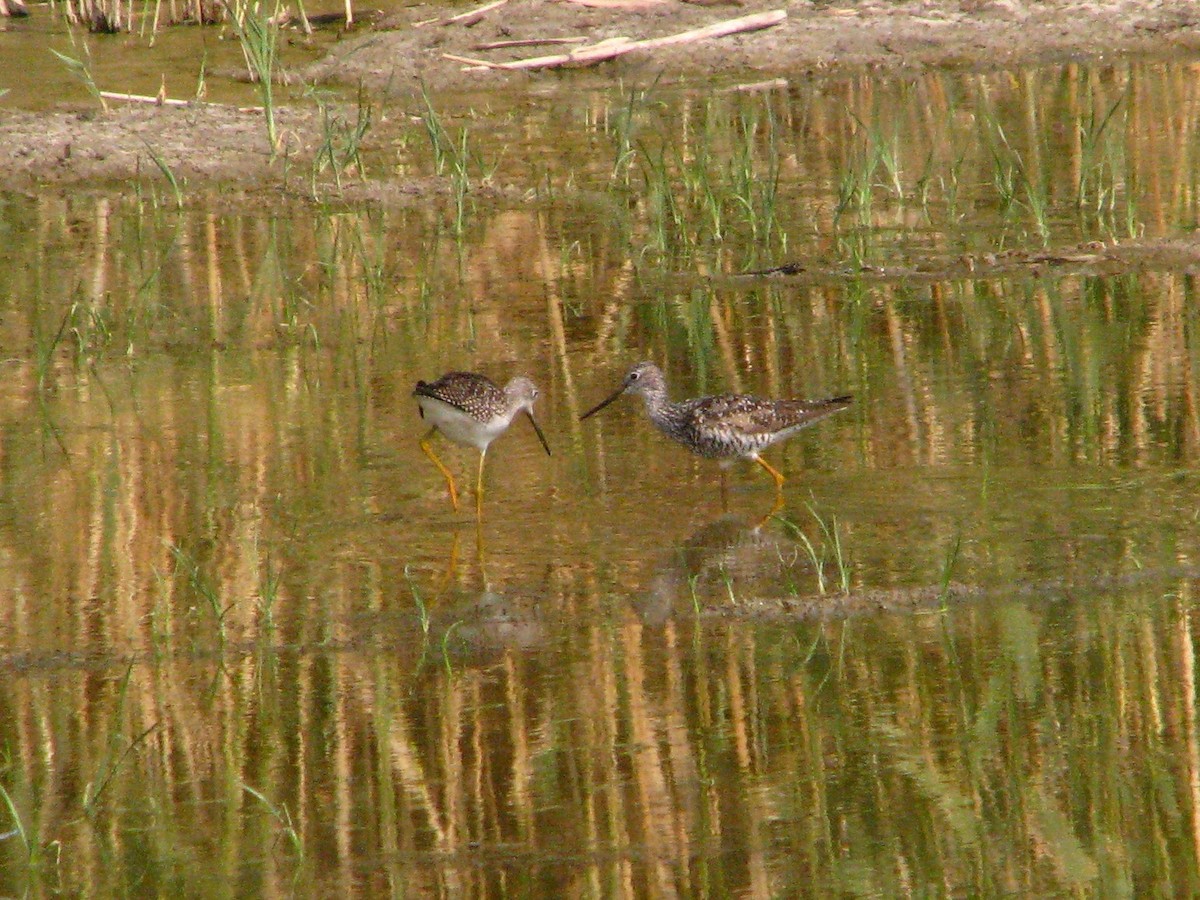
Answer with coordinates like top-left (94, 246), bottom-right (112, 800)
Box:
top-left (307, 0), bottom-right (1200, 89)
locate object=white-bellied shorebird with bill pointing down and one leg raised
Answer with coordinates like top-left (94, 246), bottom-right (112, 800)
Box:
top-left (413, 372), bottom-right (550, 516)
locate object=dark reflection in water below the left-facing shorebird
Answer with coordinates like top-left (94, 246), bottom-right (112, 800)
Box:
top-left (638, 516), bottom-right (802, 623)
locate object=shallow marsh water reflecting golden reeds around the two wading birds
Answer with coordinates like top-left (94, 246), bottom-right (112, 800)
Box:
top-left (0, 56), bottom-right (1200, 896)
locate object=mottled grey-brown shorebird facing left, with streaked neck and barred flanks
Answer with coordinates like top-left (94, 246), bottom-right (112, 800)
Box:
top-left (580, 362), bottom-right (852, 497)
